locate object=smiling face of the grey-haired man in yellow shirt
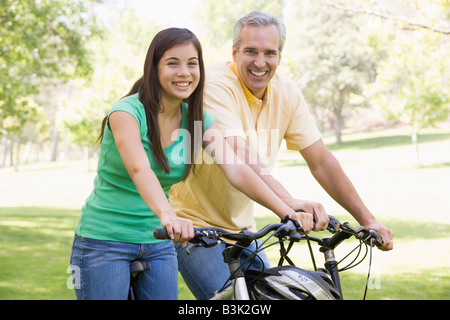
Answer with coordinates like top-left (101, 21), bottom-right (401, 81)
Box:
top-left (233, 25), bottom-right (281, 99)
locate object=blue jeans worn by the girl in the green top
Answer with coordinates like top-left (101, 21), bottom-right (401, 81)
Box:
top-left (70, 235), bottom-right (178, 300)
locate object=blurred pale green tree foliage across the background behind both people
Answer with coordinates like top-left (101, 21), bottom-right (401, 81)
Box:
top-left (0, 0), bottom-right (450, 165)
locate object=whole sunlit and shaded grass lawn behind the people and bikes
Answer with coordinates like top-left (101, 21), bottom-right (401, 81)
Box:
top-left (0, 130), bottom-right (450, 300)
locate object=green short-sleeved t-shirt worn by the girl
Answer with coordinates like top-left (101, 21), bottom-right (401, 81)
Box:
top-left (75, 94), bottom-right (214, 244)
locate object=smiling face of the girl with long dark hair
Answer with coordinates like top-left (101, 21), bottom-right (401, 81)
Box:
top-left (158, 43), bottom-right (200, 105)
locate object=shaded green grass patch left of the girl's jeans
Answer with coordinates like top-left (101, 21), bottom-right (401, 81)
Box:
top-left (0, 207), bottom-right (78, 300)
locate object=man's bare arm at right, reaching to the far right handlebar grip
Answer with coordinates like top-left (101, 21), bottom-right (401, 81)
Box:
top-left (300, 140), bottom-right (393, 250)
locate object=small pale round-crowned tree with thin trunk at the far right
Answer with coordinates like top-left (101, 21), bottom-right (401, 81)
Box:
top-left (370, 31), bottom-right (450, 164)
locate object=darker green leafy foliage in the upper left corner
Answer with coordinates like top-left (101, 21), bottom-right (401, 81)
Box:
top-left (0, 0), bottom-right (101, 134)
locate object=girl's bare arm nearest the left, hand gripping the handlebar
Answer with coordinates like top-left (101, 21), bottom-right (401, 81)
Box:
top-left (109, 111), bottom-right (194, 243)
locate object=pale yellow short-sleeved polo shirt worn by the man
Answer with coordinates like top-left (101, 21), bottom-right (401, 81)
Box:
top-left (169, 63), bottom-right (321, 231)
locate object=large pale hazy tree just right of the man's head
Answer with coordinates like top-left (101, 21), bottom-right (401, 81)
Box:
top-left (282, 1), bottom-right (377, 143)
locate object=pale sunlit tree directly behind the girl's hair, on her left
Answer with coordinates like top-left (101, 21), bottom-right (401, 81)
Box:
top-left (61, 9), bottom-right (161, 167)
